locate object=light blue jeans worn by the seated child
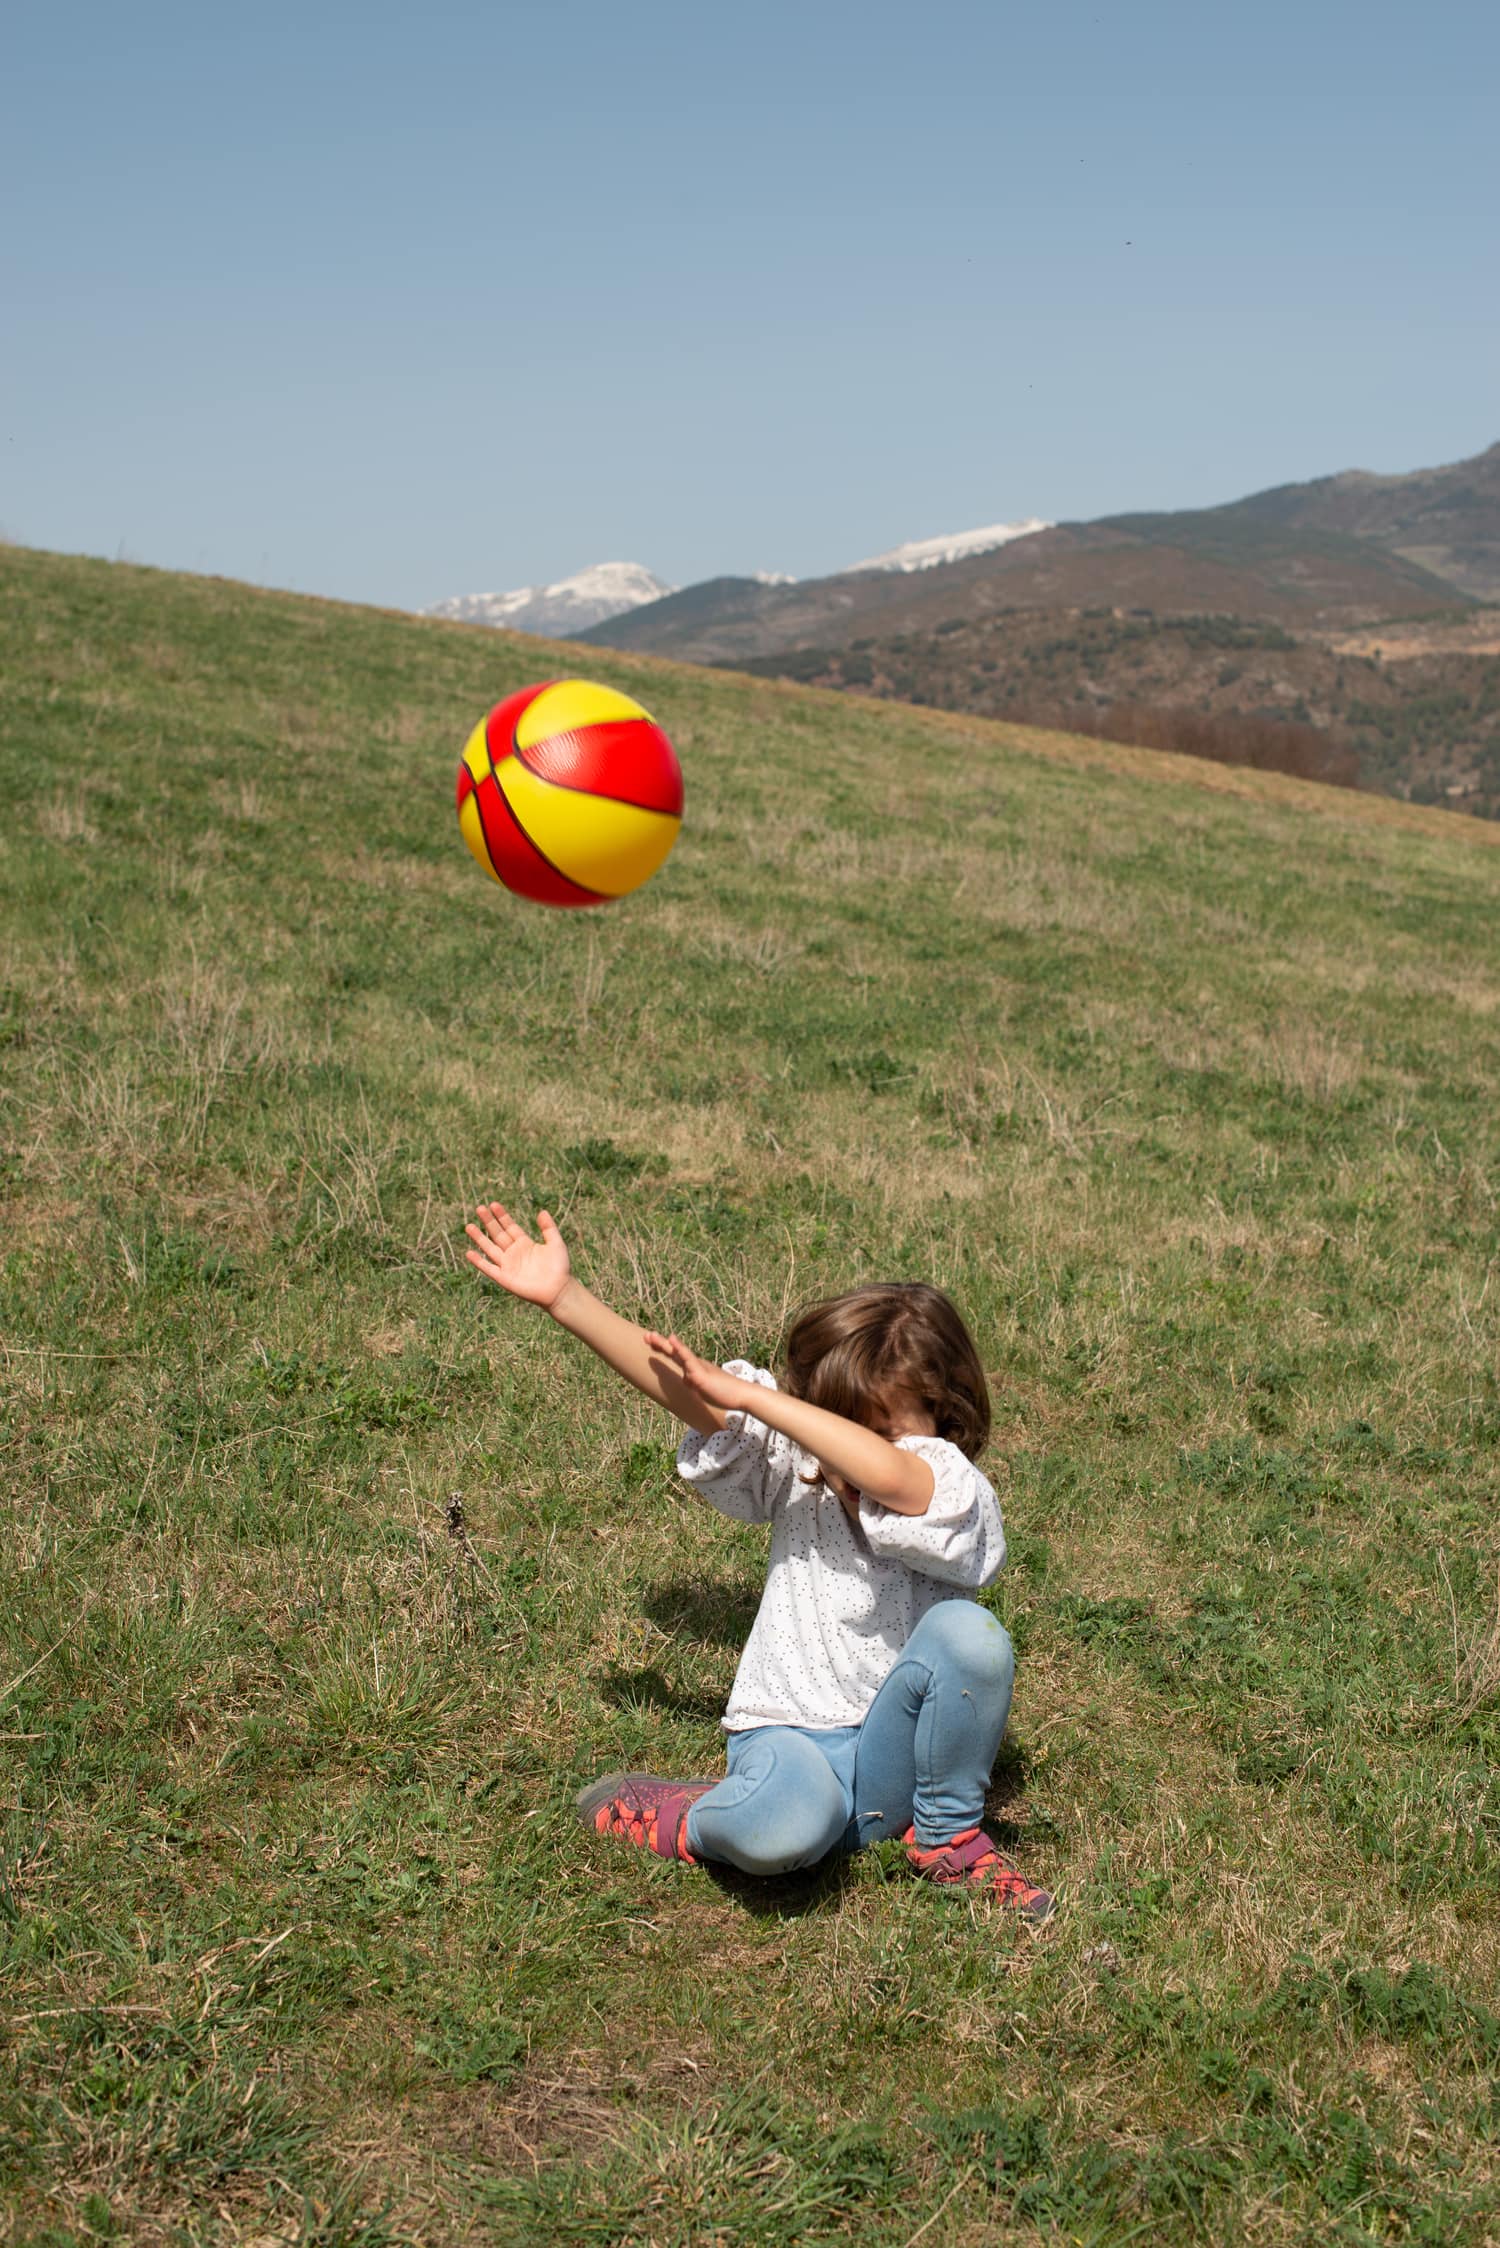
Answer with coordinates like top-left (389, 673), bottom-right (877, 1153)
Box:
top-left (686, 1601), bottom-right (1014, 1873)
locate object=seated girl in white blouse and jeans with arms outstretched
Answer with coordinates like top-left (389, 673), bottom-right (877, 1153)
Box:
top-left (468, 1203), bottom-right (1052, 1920)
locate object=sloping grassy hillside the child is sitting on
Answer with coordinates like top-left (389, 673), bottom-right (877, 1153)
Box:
top-left (0, 551), bottom-right (1500, 2248)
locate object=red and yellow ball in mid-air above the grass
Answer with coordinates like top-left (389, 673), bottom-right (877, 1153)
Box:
top-left (459, 679), bottom-right (681, 906)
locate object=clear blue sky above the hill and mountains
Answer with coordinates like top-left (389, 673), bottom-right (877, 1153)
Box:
top-left (0, 0), bottom-right (1500, 607)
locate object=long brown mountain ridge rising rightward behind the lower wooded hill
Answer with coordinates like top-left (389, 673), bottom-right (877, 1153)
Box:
top-left (585, 445), bottom-right (1500, 663)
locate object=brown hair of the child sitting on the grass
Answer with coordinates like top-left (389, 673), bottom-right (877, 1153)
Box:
top-left (783, 1279), bottom-right (990, 1459)
